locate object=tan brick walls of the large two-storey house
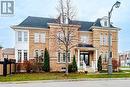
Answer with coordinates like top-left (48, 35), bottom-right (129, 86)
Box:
top-left (29, 24), bottom-right (118, 71)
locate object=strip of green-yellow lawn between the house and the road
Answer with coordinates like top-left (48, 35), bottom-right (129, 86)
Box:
top-left (0, 71), bottom-right (130, 82)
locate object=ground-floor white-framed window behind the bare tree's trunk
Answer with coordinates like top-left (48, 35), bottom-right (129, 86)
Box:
top-left (58, 52), bottom-right (70, 63)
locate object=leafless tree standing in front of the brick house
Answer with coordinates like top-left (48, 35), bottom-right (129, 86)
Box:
top-left (56, 0), bottom-right (78, 75)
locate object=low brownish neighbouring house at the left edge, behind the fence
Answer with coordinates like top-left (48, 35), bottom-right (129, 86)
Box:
top-left (0, 48), bottom-right (15, 61)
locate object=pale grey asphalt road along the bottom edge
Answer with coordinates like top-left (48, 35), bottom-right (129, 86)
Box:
top-left (0, 80), bottom-right (130, 87)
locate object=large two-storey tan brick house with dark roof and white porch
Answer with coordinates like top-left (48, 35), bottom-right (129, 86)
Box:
top-left (11, 16), bottom-right (120, 72)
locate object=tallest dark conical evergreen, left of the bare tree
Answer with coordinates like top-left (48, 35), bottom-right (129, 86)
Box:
top-left (43, 48), bottom-right (50, 72)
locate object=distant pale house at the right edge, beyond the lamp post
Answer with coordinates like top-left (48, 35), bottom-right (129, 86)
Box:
top-left (119, 51), bottom-right (130, 66)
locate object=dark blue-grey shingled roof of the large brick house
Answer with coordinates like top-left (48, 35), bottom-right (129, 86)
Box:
top-left (17, 16), bottom-right (113, 31)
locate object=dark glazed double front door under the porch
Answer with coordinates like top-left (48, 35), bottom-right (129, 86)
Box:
top-left (80, 53), bottom-right (89, 68)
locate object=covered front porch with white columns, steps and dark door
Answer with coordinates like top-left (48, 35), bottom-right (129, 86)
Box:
top-left (75, 46), bottom-right (98, 72)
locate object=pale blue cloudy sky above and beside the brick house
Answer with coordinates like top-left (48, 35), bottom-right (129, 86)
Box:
top-left (0, 0), bottom-right (130, 52)
